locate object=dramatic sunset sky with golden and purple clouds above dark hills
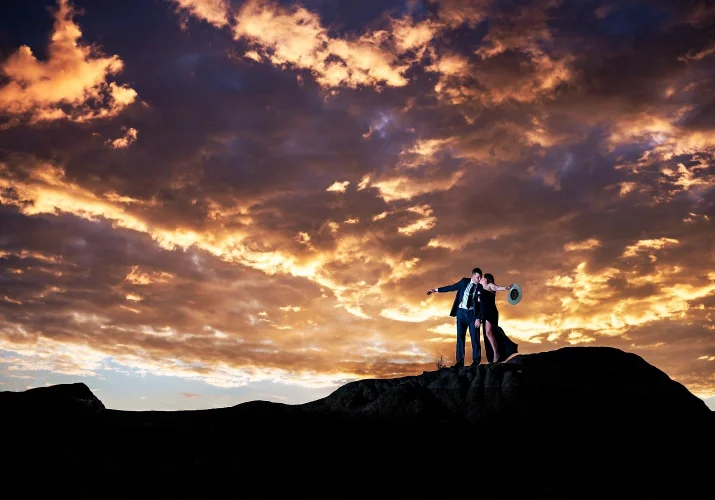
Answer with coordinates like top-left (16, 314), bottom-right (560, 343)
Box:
top-left (0, 0), bottom-right (715, 410)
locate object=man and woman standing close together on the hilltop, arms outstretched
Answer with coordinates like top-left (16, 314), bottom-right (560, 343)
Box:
top-left (427, 267), bottom-right (518, 367)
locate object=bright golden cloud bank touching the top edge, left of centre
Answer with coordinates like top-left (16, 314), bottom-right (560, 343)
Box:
top-left (173, 0), bottom-right (498, 94)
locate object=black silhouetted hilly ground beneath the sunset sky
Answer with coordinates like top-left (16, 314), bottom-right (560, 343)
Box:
top-left (0, 347), bottom-right (715, 499)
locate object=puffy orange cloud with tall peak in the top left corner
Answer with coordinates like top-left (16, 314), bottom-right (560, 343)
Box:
top-left (0, 0), bottom-right (137, 122)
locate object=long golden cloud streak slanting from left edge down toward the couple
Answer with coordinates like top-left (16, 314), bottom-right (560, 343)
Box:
top-left (0, 158), bottom-right (448, 326)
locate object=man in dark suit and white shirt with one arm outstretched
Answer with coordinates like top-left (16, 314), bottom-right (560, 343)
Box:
top-left (427, 267), bottom-right (482, 368)
